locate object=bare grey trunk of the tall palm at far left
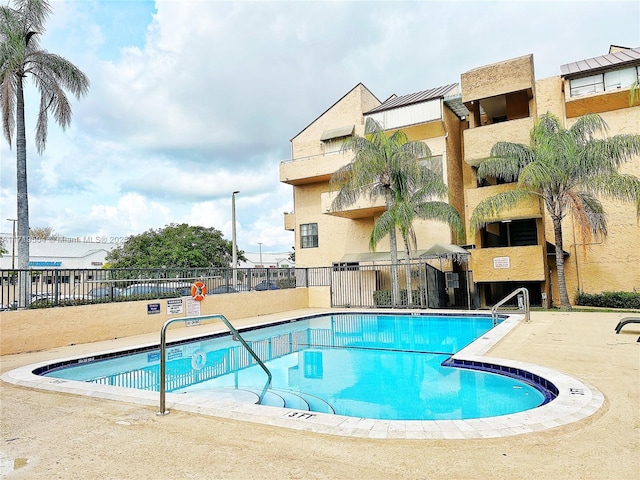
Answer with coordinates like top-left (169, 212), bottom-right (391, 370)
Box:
top-left (16, 76), bottom-right (30, 308)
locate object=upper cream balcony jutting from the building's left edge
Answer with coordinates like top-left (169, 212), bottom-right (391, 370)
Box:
top-left (280, 152), bottom-right (353, 185)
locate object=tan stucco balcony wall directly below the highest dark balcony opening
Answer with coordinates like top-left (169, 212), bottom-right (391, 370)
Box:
top-left (463, 117), bottom-right (535, 166)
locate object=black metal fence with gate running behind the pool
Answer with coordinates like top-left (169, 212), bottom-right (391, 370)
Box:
top-left (0, 261), bottom-right (474, 310)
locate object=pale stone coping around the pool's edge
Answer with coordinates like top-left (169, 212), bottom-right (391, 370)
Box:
top-left (0, 309), bottom-right (604, 439)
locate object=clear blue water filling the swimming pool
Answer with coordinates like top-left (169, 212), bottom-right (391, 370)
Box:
top-left (36, 314), bottom-right (549, 420)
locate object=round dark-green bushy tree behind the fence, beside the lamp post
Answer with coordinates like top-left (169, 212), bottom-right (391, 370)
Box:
top-left (106, 223), bottom-right (246, 268)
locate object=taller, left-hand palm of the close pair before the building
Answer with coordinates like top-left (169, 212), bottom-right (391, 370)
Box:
top-left (329, 118), bottom-right (450, 305)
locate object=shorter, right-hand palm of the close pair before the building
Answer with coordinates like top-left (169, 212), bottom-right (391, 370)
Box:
top-left (369, 171), bottom-right (464, 305)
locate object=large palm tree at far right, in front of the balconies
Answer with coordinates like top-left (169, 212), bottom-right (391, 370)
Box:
top-left (470, 113), bottom-right (640, 309)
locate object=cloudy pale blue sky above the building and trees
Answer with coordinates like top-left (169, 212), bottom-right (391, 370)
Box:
top-left (0, 0), bottom-right (640, 252)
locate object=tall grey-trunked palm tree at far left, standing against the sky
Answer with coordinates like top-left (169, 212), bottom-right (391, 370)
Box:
top-left (0, 0), bottom-right (89, 306)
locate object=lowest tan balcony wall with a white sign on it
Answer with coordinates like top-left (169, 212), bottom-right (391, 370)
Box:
top-left (470, 245), bottom-right (546, 283)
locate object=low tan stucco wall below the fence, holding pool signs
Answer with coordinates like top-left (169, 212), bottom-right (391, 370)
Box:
top-left (0, 288), bottom-right (310, 355)
